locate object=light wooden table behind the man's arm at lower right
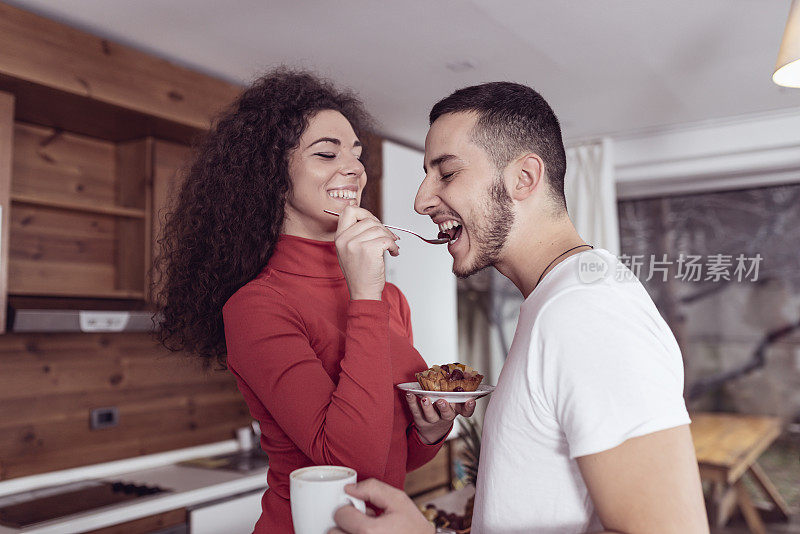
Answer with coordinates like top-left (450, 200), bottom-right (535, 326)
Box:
top-left (690, 413), bottom-right (789, 534)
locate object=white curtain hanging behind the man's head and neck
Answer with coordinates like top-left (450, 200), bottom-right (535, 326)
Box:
top-left (564, 138), bottom-right (620, 256)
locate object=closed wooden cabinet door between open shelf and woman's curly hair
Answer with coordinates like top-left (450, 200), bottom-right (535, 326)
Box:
top-left (150, 139), bottom-right (191, 302)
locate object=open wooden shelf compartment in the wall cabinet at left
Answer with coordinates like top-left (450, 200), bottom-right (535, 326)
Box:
top-left (7, 121), bottom-right (153, 300)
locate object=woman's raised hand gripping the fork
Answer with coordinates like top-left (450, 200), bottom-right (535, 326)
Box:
top-left (334, 206), bottom-right (400, 300)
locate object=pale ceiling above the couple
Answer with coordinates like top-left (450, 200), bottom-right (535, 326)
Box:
top-left (7, 0), bottom-right (800, 146)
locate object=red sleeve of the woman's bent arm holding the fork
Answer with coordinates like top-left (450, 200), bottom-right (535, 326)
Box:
top-left (225, 286), bottom-right (394, 477)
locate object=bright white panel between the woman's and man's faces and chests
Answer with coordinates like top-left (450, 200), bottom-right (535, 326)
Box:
top-left (383, 141), bottom-right (458, 365)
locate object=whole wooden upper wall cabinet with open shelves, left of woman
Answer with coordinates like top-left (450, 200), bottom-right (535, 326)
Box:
top-left (0, 3), bottom-right (240, 332)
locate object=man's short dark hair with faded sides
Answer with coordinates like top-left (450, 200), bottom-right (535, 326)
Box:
top-left (430, 82), bottom-right (567, 209)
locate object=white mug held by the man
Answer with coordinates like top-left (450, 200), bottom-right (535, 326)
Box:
top-left (289, 465), bottom-right (366, 534)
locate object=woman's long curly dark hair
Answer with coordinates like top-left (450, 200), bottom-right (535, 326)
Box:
top-left (153, 67), bottom-right (371, 368)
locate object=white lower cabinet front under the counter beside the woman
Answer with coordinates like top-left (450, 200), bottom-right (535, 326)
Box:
top-left (189, 490), bottom-right (264, 534)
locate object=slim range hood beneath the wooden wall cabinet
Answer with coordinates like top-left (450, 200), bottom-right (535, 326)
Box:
top-left (6, 299), bottom-right (159, 333)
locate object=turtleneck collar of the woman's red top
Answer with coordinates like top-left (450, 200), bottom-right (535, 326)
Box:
top-left (268, 234), bottom-right (344, 278)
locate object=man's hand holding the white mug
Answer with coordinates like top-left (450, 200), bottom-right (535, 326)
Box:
top-left (328, 478), bottom-right (436, 534)
